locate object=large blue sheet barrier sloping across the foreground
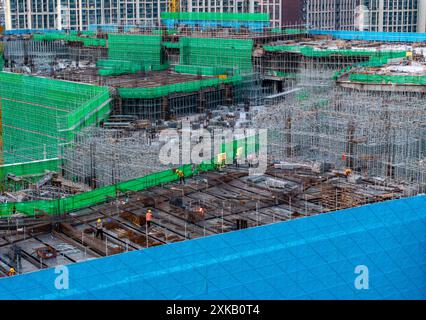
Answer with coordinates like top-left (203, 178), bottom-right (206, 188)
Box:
top-left (0, 196), bottom-right (426, 299)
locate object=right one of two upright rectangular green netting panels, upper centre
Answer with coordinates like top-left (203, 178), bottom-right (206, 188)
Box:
top-left (180, 37), bottom-right (253, 73)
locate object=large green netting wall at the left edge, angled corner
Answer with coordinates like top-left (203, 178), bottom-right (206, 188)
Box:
top-left (0, 72), bottom-right (110, 164)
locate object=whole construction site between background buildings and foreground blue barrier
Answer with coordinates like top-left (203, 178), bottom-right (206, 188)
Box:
top-left (0, 13), bottom-right (426, 288)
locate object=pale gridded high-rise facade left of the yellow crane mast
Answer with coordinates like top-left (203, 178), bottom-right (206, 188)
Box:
top-left (4, 0), bottom-right (168, 30)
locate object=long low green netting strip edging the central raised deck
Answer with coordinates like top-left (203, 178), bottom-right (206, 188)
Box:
top-left (118, 75), bottom-right (242, 99)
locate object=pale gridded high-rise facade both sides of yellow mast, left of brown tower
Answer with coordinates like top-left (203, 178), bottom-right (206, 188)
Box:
top-left (4, 0), bottom-right (289, 30)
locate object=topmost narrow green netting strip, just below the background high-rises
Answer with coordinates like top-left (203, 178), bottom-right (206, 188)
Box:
top-left (161, 12), bottom-right (269, 22)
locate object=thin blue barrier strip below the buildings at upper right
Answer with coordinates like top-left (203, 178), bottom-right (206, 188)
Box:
top-left (309, 30), bottom-right (426, 42)
